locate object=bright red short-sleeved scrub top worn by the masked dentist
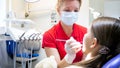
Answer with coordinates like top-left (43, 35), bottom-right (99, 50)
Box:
top-left (42, 22), bottom-right (87, 62)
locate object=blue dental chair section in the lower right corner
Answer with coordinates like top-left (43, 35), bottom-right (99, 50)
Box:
top-left (102, 54), bottom-right (120, 68)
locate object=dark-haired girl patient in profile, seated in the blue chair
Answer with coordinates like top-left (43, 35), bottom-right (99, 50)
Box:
top-left (66, 17), bottom-right (120, 68)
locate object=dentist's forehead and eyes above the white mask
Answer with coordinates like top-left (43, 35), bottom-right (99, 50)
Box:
top-left (58, 0), bottom-right (80, 15)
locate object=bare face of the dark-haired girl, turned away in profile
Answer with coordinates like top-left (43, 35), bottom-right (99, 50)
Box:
top-left (82, 28), bottom-right (94, 54)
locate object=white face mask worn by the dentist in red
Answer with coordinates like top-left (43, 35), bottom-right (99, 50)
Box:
top-left (61, 11), bottom-right (78, 25)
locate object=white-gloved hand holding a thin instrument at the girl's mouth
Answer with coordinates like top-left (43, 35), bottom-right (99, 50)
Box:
top-left (65, 37), bottom-right (82, 64)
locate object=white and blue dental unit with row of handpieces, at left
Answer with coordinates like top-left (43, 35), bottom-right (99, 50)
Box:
top-left (2, 11), bottom-right (42, 68)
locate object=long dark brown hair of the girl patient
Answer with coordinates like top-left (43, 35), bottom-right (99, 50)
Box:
top-left (80, 17), bottom-right (120, 68)
